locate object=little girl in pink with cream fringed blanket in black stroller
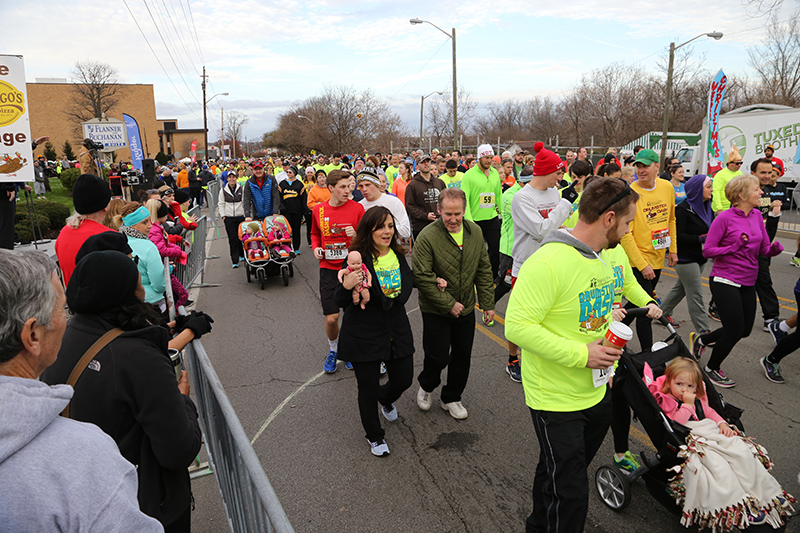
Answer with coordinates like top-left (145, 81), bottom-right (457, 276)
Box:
top-left (644, 357), bottom-right (795, 530)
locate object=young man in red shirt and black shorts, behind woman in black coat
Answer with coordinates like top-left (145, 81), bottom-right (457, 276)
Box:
top-left (311, 170), bottom-right (364, 374)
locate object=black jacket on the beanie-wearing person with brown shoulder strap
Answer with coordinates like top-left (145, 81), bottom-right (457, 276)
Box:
top-left (42, 314), bottom-right (201, 524)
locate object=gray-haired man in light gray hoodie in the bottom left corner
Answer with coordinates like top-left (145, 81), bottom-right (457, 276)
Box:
top-left (0, 250), bottom-right (163, 532)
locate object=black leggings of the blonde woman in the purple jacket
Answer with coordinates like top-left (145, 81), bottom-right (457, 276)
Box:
top-left (699, 279), bottom-right (756, 370)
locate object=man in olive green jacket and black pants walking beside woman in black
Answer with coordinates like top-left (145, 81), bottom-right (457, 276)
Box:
top-left (413, 188), bottom-right (494, 420)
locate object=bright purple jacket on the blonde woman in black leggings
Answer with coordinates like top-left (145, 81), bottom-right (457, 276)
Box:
top-left (703, 207), bottom-right (783, 287)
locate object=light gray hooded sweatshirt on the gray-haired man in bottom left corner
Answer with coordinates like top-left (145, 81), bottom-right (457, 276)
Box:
top-left (0, 376), bottom-right (164, 533)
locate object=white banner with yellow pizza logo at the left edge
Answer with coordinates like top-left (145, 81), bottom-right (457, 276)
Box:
top-left (0, 55), bottom-right (33, 182)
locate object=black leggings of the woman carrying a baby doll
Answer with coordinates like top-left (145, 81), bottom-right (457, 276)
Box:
top-left (353, 356), bottom-right (414, 442)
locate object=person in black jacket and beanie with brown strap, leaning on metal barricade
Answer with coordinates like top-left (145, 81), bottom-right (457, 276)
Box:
top-left (42, 251), bottom-right (201, 531)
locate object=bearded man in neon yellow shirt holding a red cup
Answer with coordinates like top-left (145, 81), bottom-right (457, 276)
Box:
top-left (505, 177), bottom-right (660, 532)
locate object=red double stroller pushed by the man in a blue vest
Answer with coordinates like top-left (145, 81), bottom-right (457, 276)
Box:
top-left (239, 215), bottom-right (295, 290)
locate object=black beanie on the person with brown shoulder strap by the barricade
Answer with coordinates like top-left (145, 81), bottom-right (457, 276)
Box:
top-left (67, 250), bottom-right (139, 314)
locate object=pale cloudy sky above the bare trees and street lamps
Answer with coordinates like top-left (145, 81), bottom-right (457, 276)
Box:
top-left (7, 0), bottom-right (798, 138)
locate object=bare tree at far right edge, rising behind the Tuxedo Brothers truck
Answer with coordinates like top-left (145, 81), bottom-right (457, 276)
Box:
top-left (747, 14), bottom-right (800, 107)
